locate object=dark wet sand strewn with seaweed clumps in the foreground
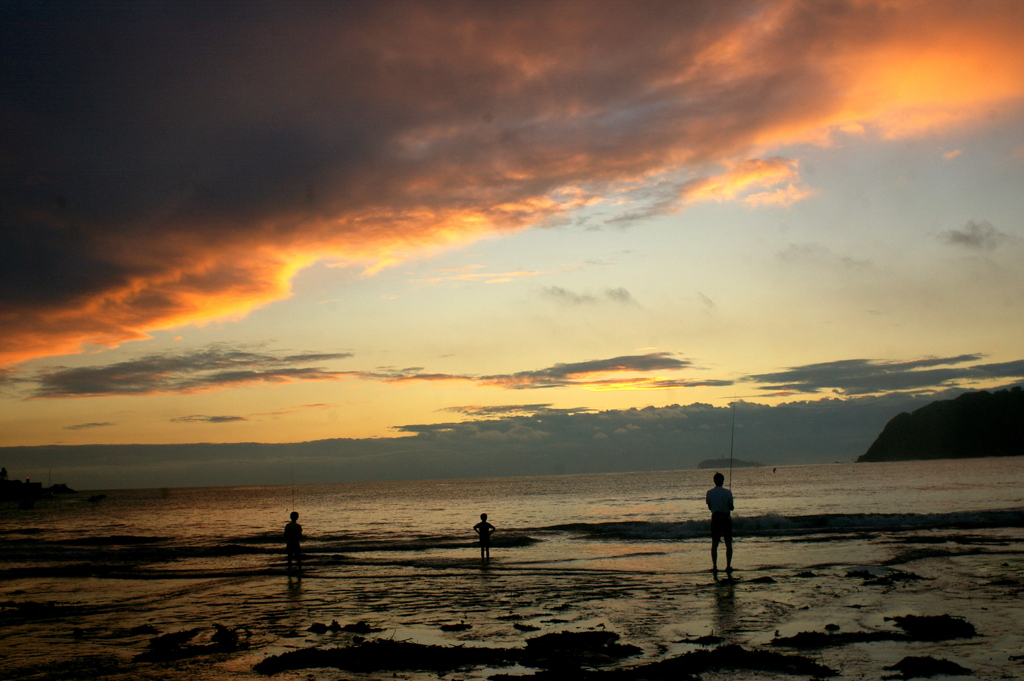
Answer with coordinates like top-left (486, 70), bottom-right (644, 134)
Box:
top-left (0, 527), bottom-right (1024, 681)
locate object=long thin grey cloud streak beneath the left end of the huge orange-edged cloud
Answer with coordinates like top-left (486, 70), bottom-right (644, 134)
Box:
top-left (31, 346), bottom-right (352, 397)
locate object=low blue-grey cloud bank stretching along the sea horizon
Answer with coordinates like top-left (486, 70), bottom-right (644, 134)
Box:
top-left (0, 386), bottom-right (1009, 488)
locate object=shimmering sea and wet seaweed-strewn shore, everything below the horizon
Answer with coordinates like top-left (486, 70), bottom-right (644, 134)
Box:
top-left (0, 458), bottom-right (1024, 679)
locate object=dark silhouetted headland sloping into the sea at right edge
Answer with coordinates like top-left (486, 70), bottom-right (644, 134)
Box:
top-left (857, 386), bottom-right (1024, 462)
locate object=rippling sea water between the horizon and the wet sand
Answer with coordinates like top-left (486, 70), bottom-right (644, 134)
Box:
top-left (0, 457), bottom-right (1024, 569)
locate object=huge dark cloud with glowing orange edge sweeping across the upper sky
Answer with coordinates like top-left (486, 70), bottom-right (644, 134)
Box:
top-left (0, 0), bottom-right (1024, 364)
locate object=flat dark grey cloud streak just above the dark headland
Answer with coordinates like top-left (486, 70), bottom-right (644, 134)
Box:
top-left (743, 354), bottom-right (1024, 395)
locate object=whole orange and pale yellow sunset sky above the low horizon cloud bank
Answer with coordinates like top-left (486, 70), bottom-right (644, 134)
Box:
top-left (0, 0), bottom-right (1024, 484)
